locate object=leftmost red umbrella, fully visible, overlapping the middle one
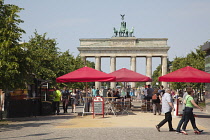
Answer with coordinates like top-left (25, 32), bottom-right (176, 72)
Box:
top-left (56, 66), bottom-right (116, 83)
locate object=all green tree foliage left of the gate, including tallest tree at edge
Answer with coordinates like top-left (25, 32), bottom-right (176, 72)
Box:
top-left (0, 0), bottom-right (94, 90)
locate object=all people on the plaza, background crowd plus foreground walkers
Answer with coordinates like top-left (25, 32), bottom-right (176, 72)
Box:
top-left (50, 85), bottom-right (203, 135)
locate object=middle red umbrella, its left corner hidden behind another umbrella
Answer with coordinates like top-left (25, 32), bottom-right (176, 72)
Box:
top-left (110, 68), bottom-right (152, 82)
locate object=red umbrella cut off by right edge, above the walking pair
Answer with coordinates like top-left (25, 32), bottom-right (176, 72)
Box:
top-left (158, 66), bottom-right (210, 83)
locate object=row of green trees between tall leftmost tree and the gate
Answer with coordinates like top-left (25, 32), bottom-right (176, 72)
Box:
top-left (25, 31), bottom-right (94, 88)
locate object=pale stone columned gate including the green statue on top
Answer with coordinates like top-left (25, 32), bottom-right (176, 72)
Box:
top-left (78, 15), bottom-right (170, 88)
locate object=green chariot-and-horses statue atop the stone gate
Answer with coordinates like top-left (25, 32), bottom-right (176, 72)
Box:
top-left (113, 14), bottom-right (134, 37)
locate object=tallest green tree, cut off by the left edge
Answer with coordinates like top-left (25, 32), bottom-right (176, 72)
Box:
top-left (0, 0), bottom-right (26, 89)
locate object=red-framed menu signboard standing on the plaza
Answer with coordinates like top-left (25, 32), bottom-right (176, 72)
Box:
top-left (93, 96), bottom-right (104, 118)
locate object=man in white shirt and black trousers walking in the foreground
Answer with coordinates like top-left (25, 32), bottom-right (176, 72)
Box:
top-left (156, 89), bottom-right (176, 132)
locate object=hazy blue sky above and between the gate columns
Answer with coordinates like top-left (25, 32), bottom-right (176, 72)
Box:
top-left (5, 0), bottom-right (210, 75)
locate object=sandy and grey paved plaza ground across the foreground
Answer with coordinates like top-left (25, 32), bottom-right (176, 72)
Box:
top-left (0, 102), bottom-right (210, 140)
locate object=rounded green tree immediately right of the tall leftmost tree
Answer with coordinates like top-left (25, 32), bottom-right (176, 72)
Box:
top-left (25, 31), bottom-right (60, 85)
